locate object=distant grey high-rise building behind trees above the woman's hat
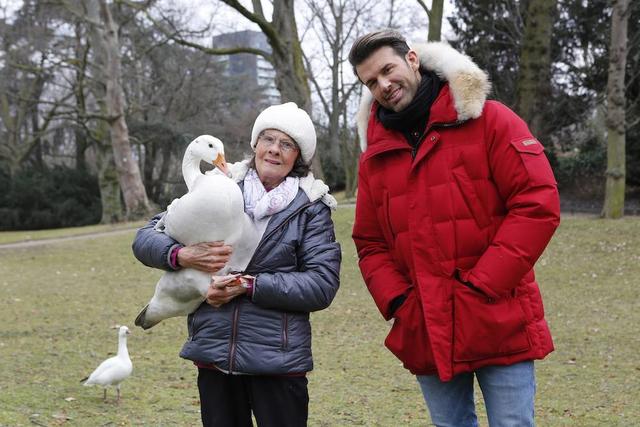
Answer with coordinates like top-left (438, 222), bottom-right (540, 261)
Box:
top-left (212, 30), bottom-right (280, 104)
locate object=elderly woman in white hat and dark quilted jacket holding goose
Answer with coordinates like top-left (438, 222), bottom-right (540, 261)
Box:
top-left (133, 103), bottom-right (341, 426)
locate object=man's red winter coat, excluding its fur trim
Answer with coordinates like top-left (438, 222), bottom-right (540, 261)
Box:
top-left (353, 78), bottom-right (560, 381)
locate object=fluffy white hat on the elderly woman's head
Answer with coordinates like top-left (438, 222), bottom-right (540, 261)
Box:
top-left (251, 102), bottom-right (316, 164)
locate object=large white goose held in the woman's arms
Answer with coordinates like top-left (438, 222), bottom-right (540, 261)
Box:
top-left (135, 135), bottom-right (258, 329)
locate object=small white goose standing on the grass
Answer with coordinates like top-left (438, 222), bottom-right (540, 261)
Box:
top-left (80, 326), bottom-right (133, 403)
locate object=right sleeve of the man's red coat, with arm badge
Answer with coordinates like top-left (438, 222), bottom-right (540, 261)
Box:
top-left (462, 102), bottom-right (560, 297)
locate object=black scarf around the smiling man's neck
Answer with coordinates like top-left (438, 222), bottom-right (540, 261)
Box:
top-left (377, 69), bottom-right (443, 146)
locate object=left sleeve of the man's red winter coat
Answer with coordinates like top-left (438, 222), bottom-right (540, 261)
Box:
top-left (352, 163), bottom-right (411, 320)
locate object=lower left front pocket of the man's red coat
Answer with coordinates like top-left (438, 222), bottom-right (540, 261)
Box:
top-left (384, 289), bottom-right (436, 374)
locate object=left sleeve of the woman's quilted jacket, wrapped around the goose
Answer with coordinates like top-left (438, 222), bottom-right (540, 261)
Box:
top-left (131, 212), bottom-right (180, 271)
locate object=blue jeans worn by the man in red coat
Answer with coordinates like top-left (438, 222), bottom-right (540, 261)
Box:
top-left (417, 361), bottom-right (536, 427)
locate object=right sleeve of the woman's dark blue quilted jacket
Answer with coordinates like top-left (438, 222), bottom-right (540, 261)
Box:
top-left (252, 203), bottom-right (342, 312)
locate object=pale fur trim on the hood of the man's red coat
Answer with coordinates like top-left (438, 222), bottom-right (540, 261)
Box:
top-left (356, 42), bottom-right (491, 152)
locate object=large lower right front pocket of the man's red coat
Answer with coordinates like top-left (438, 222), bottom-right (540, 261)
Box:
top-left (453, 281), bottom-right (531, 362)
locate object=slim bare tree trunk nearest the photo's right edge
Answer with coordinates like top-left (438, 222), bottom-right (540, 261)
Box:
top-left (602, 0), bottom-right (630, 218)
